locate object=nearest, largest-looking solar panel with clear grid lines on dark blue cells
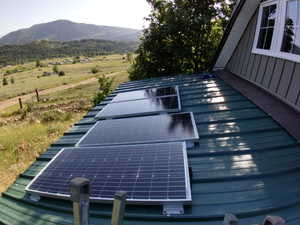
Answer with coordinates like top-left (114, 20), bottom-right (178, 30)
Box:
top-left (26, 142), bottom-right (191, 204)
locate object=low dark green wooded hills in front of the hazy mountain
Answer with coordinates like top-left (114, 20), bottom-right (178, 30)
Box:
top-left (0, 40), bottom-right (137, 66)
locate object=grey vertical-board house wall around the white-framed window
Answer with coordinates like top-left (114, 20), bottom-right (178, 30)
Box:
top-left (226, 10), bottom-right (300, 110)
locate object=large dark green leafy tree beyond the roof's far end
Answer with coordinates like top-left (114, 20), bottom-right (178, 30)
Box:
top-left (129, 0), bottom-right (237, 80)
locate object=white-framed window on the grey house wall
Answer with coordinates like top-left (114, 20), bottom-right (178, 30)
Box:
top-left (253, 0), bottom-right (300, 62)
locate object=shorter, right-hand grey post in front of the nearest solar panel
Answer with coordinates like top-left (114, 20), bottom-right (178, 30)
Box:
top-left (111, 191), bottom-right (127, 225)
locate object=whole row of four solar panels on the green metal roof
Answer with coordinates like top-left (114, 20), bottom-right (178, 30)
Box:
top-left (26, 84), bottom-right (199, 209)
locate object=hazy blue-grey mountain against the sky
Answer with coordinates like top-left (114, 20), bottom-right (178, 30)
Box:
top-left (0, 20), bottom-right (141, 45)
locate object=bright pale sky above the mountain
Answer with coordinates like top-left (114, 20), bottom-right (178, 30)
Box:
top-left (0, 0), bottom-right (150, 37)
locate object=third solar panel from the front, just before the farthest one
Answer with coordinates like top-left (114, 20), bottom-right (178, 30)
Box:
top-left (96, 96), bottom-right (181, 119)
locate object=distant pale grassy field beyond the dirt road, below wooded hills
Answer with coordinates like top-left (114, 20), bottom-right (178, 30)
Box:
top-left (0, 55), bottom-right (129, 101)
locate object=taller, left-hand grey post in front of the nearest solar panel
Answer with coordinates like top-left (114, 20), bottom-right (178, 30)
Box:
top-left (70, 177), bottom-right (90, 225)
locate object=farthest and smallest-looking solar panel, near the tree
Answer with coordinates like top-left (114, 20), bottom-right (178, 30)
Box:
top-left (112, 86), bottom-right (178, 102)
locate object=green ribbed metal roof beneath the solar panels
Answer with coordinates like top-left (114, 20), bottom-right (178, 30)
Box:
top-left (0, 75), bottom-right (300, 225)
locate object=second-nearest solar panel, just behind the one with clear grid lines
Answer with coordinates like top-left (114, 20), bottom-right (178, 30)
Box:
top-left (77, 113), bottom-right (199, 147)
